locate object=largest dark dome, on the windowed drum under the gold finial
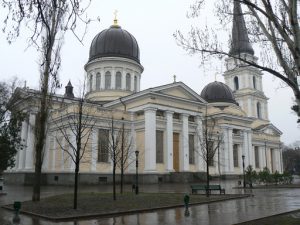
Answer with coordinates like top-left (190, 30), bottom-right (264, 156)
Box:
top-left (89, 25), bottom-right (140, 64)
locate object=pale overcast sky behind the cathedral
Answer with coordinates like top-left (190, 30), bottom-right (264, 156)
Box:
top-left (0, 0), bottom-right (300, 144)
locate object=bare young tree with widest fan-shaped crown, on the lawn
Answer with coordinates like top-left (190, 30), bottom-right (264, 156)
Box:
top-left (52, 84), bottom-right (99, 209)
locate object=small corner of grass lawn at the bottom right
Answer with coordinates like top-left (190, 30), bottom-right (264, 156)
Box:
top-left (237, 210), bottom-right (300, 225)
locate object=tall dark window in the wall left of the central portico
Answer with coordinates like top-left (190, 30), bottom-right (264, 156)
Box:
top-left (98, 129), bottom-right (109, 162)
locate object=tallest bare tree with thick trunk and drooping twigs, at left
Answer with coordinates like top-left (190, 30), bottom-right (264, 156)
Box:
top-left (2, 0), bottom-right (90, 201)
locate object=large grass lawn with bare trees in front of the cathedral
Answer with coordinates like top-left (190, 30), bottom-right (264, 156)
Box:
top-left (3, 192), bottom-right (247, 220)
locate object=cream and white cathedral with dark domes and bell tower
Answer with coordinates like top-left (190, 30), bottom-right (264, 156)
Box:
top-left (6, 1), bottom-right (283, 184)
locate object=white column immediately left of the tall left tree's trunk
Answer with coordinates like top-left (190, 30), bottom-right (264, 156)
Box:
top-left (25, 113), bottom-right (35, 170)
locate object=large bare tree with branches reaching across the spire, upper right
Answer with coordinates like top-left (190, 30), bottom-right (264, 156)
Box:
top-left (174, 0), bottom-right (300, 122)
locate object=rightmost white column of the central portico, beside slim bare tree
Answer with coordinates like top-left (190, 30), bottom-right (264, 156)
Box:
top-left (195, 116), bottom-right (205, 171)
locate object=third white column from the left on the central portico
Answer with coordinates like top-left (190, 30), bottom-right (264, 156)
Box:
top-left (179, 114), bottom-right (190, 171)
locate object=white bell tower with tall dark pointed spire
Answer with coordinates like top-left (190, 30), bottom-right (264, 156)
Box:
top-left (223, 1), bottom-right (269, 120)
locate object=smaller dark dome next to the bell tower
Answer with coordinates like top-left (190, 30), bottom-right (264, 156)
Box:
top-left (201, 81), bottom-right (237, 104)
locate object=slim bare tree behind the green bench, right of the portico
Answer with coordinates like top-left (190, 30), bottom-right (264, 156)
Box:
top-left (196, 109), bottom-right (223, 196)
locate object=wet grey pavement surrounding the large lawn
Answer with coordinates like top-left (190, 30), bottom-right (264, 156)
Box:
top-left (0, 180), bottom-right (300, 225)
